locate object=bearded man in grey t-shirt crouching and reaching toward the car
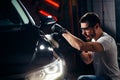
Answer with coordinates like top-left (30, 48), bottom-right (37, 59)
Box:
top-left (52, 12), bottom-right (120, 80)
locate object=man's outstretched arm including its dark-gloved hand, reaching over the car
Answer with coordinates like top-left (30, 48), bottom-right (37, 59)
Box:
top-left (51, 24), bottom-right (104, 52)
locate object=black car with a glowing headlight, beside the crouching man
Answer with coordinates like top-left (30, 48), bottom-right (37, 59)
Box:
top-left (0, 0), bottom-right (65, 80)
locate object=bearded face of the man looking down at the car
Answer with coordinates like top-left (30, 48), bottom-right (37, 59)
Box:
top-left (80, 23), bottom-right (96, 41)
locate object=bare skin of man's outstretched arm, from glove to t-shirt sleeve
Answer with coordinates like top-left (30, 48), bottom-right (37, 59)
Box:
top-left (62, 31), bottom-right (104, 52)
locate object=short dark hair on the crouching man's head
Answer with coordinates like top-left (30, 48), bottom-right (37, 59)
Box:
top-left (79, 12), bottom-right (100, 27)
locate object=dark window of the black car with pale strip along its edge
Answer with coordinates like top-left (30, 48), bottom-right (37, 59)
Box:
top-left (0, 0), bottom-right (28, 26)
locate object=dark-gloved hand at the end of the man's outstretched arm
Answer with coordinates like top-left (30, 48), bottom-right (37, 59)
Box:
top-left (51, 23), bottom-right (67, 34)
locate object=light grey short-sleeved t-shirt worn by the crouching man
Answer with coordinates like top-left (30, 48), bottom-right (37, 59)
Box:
top-left (92, 32), bottom-right (120, 80)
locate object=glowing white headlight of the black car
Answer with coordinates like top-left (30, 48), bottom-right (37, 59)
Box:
top-left (26, 59), bottom-right (64, 80)
